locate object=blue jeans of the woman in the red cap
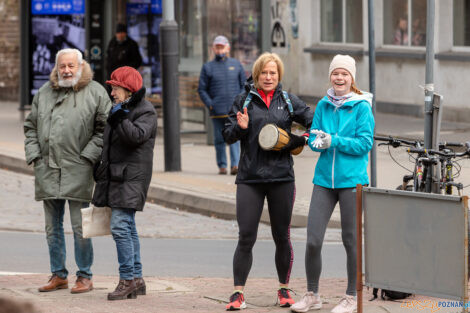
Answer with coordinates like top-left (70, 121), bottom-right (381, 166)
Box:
top-left (111, 209), bottom-right (142, 280)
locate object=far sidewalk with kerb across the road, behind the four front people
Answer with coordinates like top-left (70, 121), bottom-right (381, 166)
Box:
top-left (0, 102), bottom-right (470, 228)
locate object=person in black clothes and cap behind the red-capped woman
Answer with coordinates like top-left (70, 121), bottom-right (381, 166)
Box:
top-left (106, 23), bottom-right (142, 77)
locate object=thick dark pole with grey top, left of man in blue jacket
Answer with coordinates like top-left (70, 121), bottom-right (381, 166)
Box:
top-left (160, 0), bottom-right (181, 172)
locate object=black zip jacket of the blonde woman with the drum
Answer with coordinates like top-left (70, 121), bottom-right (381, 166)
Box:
top-left (223, 84), bottom-right (313, 184)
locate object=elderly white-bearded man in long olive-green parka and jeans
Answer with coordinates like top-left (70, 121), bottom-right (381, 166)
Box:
top-left (24, 49), bottom-right (111, 293)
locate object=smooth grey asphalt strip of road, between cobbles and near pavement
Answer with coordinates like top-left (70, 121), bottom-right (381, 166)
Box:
top-left (0, 232), bottom-right (346, 278)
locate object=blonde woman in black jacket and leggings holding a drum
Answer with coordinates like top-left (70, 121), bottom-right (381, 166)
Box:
top-left (223, 52), bottom-right (313, 310)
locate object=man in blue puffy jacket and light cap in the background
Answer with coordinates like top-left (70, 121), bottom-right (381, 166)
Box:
top-left (197, 36), bottom-right (246, 175)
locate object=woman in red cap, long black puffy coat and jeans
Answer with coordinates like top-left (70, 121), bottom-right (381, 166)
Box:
top-left (92, 66), bottom-right (157, 300)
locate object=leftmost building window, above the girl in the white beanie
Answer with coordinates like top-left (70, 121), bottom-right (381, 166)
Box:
top-left (321, 0), bottom-right (363, 43)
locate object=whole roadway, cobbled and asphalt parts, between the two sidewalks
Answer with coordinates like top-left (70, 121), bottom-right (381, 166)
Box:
top-left (0, 170), bottom-right (346, 277)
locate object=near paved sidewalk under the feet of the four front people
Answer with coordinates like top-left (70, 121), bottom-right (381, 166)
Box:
top-left (0, 273), bottom-right (462, 313)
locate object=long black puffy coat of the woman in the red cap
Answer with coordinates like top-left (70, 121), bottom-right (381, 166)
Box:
top-left (92, 88), bottom-right (157, 211)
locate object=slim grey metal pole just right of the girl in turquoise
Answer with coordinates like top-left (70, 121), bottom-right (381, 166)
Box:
top-left (368, 0), bottom-right (377, 187)
